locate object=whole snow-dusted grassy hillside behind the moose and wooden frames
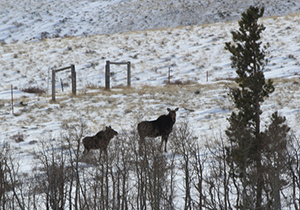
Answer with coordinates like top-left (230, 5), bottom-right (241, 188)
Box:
top-left (0, 0), bottom-right (300, 208)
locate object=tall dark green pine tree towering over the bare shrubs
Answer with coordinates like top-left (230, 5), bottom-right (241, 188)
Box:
top-left (225, 6), bottom-right (274, 210)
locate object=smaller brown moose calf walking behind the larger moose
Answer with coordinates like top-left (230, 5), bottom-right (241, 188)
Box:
top-left (82, 126), bottom-right (118, 155)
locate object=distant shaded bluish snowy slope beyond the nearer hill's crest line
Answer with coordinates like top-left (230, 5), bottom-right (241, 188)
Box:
top-left (0, 0), bottom-right (300, 43)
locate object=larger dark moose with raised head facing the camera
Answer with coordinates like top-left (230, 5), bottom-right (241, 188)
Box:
top-left (137, 108), bottom-right (178, 152)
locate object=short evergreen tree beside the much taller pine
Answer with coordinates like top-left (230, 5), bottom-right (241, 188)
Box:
top-left (262, 112), bottom-right (290, 210)
